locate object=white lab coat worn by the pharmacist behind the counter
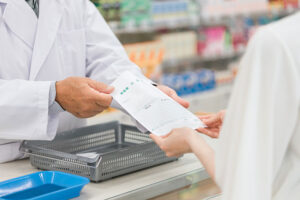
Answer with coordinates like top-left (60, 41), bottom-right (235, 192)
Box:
top-left (0, 0), bottom-right (142, 163)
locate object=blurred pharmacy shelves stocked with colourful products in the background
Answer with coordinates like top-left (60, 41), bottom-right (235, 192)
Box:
top-left (88, 0), bottom-right (300, 124)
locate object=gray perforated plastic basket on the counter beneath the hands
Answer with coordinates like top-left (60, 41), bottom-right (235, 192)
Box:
top-left (20, 122), bottom-right (178, 182)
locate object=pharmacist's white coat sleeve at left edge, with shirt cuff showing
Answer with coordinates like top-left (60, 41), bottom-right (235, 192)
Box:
top-left (0, 79), bottom-right (58, 140)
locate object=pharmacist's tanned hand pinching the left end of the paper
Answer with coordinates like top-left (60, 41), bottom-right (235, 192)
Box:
top-left (55, 77), bottom-right (114, 118)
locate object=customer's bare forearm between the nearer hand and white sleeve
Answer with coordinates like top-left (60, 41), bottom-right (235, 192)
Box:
top-left (189, 133), bottom-right (215, 180)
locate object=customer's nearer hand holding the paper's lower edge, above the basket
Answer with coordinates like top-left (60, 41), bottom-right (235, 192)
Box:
top-left (150, 128), bottom-right (195, 157)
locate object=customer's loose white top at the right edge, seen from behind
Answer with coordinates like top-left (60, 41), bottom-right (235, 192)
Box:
top-left (216, 13), bottom-right (300, 200)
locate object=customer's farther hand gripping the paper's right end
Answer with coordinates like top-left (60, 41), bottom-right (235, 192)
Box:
top-left (197, 110), bottom-right (226, 138)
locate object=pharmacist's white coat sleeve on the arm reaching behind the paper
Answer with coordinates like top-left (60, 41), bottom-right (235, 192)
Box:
top-left (85, 0), bottom-right (145, 84)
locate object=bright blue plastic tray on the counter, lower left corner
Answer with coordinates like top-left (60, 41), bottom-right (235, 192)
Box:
top-left (0, 171), bottom-right (89, 200)
